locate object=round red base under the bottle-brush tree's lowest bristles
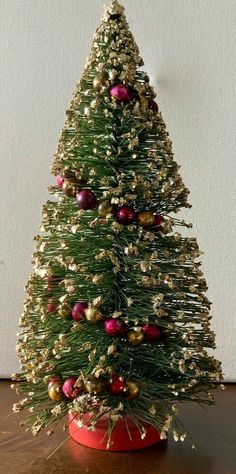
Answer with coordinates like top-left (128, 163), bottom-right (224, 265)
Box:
top-left (69, 413), bottom-right (160, 451)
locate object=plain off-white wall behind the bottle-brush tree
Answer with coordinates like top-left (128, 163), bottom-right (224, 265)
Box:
top-left (0, 0), bottom-right (236, 381)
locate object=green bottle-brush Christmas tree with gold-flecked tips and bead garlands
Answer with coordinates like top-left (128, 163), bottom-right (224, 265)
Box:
top-left (13, 0), bottom-right (222, 446)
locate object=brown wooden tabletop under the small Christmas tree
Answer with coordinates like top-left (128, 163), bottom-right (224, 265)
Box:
top-left (0, 381), bottom-right (236, 474)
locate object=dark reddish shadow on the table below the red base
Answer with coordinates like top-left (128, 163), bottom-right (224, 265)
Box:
top-left (67, 439), bottom-right (216, 474)
